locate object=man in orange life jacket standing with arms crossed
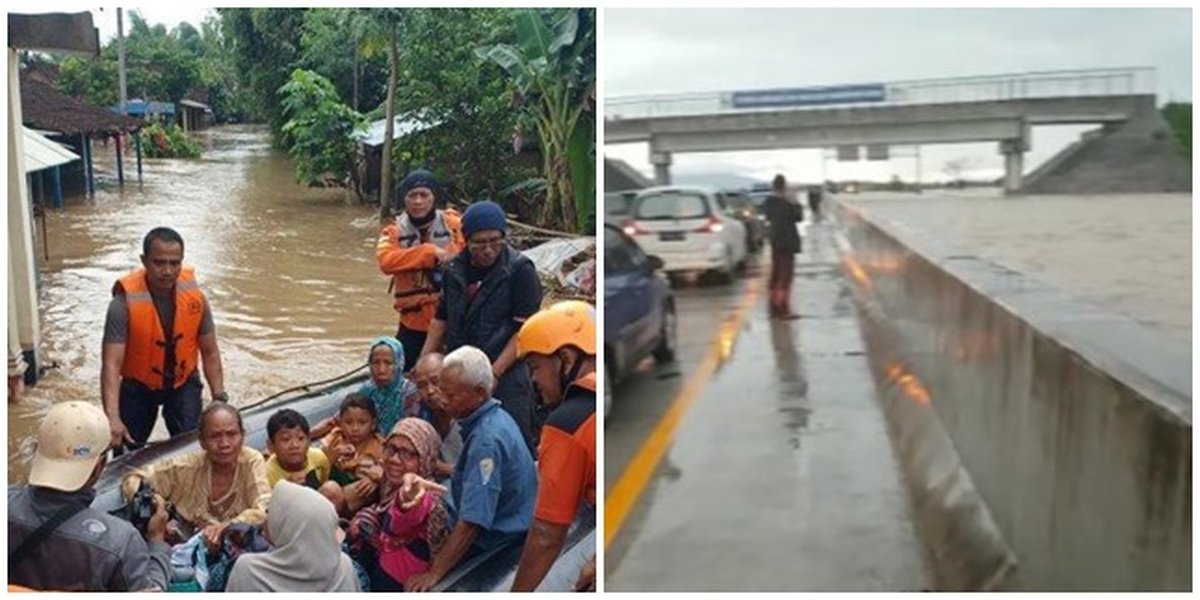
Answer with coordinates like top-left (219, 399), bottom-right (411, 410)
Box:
top-left (376, 169), bottom-right (466, 371)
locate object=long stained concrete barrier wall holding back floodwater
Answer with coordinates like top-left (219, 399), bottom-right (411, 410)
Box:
top-left (835, 202), bottom-right (1192, 590)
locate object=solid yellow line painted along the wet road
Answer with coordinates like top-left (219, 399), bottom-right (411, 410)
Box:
top-left (604, 276), bottom-right (762, 550)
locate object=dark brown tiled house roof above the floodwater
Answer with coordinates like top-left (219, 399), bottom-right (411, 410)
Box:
top-left (20, 77), bottom-right (142, 134)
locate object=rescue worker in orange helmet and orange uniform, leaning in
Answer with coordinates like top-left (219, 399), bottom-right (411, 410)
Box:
top-left (512, 300), bottom-right (596, 592)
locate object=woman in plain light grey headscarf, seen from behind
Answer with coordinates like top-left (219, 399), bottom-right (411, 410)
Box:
top-left (226, 481), bottom-right (361, 592)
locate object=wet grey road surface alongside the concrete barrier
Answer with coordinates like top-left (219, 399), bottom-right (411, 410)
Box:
top-left (605, 219), bottom-right (929, 592)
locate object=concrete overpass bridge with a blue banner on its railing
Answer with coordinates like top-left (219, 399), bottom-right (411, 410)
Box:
top-left (605, 67), bottom-right (1156, 192)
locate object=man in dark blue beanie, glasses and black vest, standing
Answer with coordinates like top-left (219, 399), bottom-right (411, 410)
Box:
top-left (424, 200), bottom-right (541, 455)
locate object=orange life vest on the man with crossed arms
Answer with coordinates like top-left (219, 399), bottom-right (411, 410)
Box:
top-left (385, 209), bottom-right (466, 331)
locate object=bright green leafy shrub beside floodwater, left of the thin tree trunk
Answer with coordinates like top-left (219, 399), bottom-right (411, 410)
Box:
top-left (278, 68), bottom-right (362, 188)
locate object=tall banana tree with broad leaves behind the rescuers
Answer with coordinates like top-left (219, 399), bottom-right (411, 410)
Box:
top-left (475, 8), bottom-right (596, 230)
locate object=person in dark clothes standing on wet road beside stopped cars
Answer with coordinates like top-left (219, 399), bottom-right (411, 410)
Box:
top-left (762, 174), bottom-right (804, 319)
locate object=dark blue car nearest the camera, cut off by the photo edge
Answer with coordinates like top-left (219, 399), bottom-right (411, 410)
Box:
top-left (604, 223), bottom-right (678, 414)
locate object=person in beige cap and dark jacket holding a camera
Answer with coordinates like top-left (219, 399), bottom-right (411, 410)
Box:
top-left (8, 401), bottom-right (170, 592)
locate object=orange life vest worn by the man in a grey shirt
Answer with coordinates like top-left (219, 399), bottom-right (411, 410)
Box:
top-left (113, 266), bottom-right (204, 390)
